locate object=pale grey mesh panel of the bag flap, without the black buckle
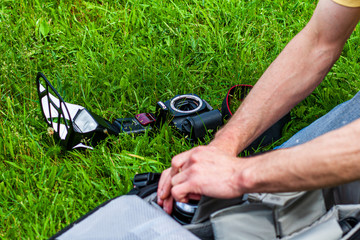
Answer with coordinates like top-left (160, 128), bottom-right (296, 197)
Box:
top-left (57, 195), bottom-right (198, 240)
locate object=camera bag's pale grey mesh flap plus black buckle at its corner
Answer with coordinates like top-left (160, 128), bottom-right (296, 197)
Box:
top-left (50, 173), bottom-right (198, 240)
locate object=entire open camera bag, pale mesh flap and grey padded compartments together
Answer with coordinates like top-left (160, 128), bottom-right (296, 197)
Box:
top-left (50, 173), bottom-right (360, 240)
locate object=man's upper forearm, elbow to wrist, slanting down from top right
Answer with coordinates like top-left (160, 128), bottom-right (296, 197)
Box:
top-left (214, 29), bottom-right (342, 154)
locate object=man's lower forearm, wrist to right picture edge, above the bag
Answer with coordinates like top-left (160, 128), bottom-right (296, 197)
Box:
top-left (236, 120), bottom-right (360, 193)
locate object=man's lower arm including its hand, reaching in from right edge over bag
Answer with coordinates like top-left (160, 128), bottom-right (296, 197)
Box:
top-left (172, 120), bottom-right (360, 201)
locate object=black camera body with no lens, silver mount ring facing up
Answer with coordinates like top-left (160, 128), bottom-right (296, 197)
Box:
top-left (155, 94), bottom-right (223, 140)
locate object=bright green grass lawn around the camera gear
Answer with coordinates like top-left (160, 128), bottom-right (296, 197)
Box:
top-left (0, 0), bottom-right (360, 239)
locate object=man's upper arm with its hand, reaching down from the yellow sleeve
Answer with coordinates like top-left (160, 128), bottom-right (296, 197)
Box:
top-left (158, 0), bottom-right (360, 211)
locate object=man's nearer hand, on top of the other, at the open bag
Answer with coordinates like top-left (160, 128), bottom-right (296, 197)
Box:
top-left (171, 146), bottom-right (242, 202)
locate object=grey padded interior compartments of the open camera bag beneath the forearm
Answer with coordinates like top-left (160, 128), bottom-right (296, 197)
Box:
top-left (205, 181), bottom-right (360, 240)
